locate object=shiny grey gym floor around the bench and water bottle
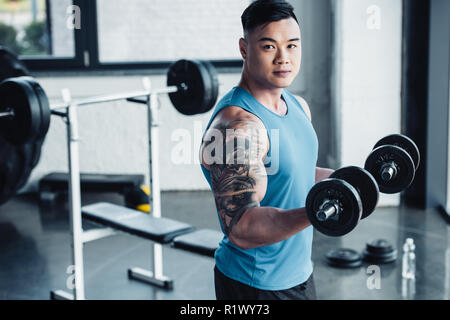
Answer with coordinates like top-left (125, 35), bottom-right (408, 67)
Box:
top-left (0, 192), bottom-right (450, 300)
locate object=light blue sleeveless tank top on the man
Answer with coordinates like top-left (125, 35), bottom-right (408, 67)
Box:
top-left (201, 87), bottom-right (318, 290)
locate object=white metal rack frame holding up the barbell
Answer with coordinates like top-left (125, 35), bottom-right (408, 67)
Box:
top-left (51, 78), bottom-right (178, 300)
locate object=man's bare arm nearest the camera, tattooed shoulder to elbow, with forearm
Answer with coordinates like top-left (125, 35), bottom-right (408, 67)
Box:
top-left (201, 107), bottom-right (310, 250)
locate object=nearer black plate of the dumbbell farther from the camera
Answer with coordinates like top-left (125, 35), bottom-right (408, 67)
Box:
top-left (364, 145), bottom-right (415, 194)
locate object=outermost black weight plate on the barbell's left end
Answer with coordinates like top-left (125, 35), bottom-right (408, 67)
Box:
top-left (0, 77), bottom-right (41, 146)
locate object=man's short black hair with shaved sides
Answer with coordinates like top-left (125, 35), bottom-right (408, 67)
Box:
top-left (241, 0), bottom-right (298, 35)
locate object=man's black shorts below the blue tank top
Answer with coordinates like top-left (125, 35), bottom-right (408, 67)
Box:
top-left (214, 267), bottom-right (317, 300)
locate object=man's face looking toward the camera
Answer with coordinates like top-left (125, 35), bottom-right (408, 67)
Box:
top-left (239, 18), bottom-right (302, 88)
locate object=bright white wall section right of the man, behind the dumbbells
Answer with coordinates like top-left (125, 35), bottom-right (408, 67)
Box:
top-left (333, 0), bottom-right (402, 205)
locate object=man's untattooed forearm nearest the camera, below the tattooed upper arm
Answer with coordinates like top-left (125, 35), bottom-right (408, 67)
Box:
top-left (229, 207), bottom-right (311, 250)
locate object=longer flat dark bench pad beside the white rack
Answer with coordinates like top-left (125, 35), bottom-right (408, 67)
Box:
top-left (81, 202), bottom-right (194, 244)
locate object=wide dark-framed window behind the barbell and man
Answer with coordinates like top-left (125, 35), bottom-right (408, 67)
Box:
top-left (0, 0), bottom-right (246, 70)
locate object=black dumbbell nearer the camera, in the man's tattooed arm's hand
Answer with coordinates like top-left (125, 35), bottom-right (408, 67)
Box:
top-left (305, 166), bottom-right (379, 237)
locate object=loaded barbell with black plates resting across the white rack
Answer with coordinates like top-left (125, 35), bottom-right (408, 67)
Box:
top-left (0, 60), bottom-right (219, 146)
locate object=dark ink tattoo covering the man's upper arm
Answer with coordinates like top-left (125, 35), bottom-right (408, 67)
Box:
top-left (210, 120), bottom-right (266, 236)
